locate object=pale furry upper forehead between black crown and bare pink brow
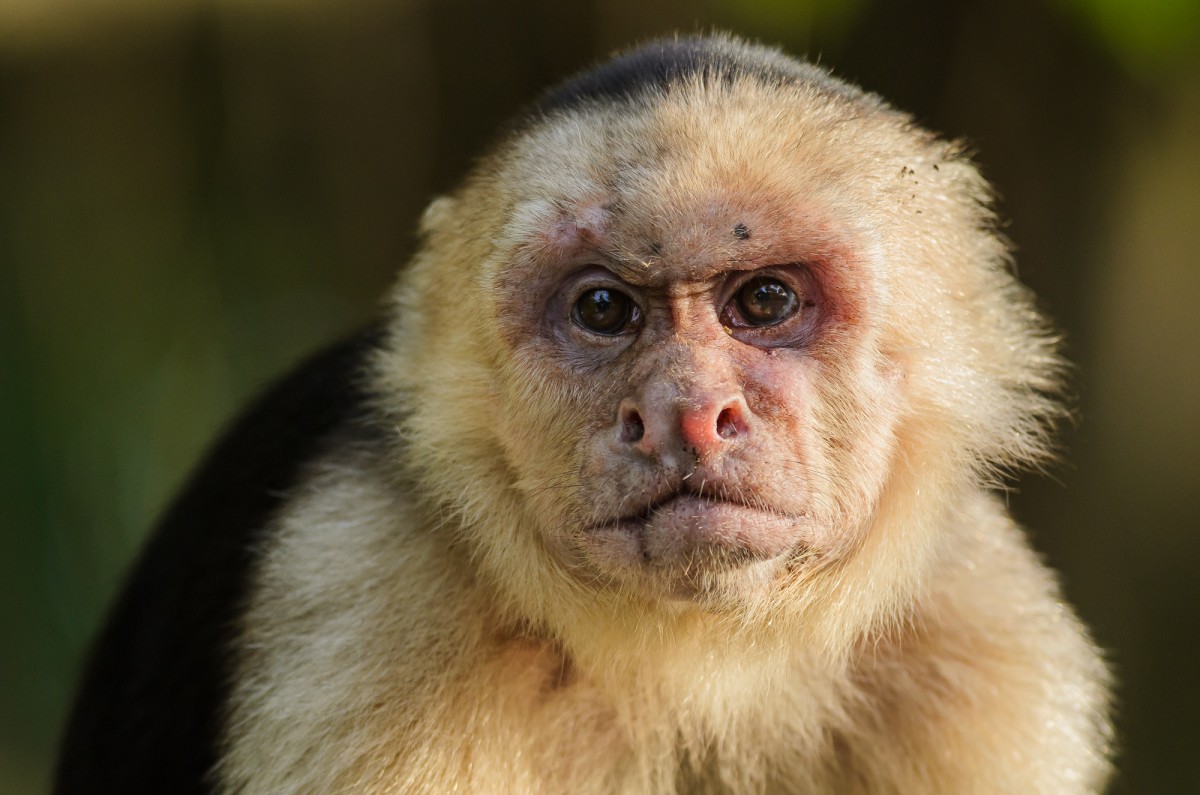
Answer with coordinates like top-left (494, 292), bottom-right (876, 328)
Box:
top-left (516, 77), bottom-right (865, 195)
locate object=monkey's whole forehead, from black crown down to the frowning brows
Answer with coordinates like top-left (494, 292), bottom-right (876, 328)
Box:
top-left (487, 77), bottom-right (892, 283)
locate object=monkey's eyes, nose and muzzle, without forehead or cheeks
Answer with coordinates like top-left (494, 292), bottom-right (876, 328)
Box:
top-left (547, 255), bottom-right (820, 591)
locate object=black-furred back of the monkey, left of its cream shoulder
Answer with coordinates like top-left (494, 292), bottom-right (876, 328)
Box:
top-left (55, 329), bottom-right (382, 794)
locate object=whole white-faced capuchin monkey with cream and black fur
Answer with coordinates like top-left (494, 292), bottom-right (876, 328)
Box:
top-left (58, 36), bottom-right (1111, 795)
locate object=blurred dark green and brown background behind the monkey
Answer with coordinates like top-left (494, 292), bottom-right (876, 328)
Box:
top-left (0, 0), bottom-right (1200, 795)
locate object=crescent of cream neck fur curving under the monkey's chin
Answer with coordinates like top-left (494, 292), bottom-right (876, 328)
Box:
top-left (484, 499), bottom-right (958, 715)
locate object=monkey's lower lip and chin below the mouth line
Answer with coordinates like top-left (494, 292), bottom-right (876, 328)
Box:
top-left (581, 494), bottom-right (806, 603)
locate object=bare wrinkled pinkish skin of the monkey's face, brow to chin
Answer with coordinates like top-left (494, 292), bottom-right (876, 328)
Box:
top-left (487, 182), bottom-right (896, 598)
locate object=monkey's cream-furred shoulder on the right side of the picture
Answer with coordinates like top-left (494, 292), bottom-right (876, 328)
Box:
top-left (840, 492), bottom-right (1111, 794)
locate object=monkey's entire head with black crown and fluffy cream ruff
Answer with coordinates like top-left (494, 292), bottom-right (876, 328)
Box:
top-left (382, 42), bottom-right (1056, 629)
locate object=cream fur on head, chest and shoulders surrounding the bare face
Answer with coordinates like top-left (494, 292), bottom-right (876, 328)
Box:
top-left (218, 39), bottom-right (1110, 794)
